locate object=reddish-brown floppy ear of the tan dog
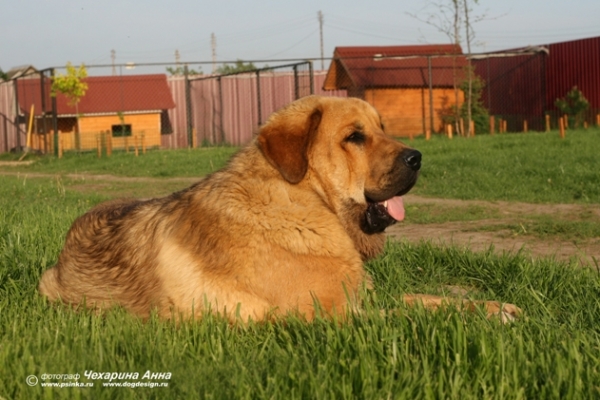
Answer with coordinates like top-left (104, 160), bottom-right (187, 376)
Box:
top-left (258, 104), bottom-right (323, 183)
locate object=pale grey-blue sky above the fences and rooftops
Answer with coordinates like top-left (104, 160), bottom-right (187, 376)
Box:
top-left (0, 0), bottom-right (600, 72)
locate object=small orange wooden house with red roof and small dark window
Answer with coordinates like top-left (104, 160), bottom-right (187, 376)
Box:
top-left (18, 74), bottom-right (175, 150)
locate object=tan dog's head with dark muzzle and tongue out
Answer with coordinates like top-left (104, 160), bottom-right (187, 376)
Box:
top-left (258, 96), bottom-right (421, 233)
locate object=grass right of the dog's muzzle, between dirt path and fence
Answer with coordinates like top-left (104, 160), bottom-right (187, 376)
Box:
top-left (409, 129), bottom-right (600, 204)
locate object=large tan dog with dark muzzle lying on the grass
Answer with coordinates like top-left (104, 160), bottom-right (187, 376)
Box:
top-left (39, 96), bottom-right (519, 321)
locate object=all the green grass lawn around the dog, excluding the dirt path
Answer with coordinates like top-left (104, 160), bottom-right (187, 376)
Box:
top-left (0, 130), bottom-right (600, 399)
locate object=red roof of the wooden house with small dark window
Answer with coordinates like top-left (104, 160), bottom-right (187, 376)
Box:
top-left (17, 74), bottom-right (175, 115)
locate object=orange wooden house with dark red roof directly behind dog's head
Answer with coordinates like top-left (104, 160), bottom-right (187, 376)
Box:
top-left (323, 44), bottom-right (466, 136)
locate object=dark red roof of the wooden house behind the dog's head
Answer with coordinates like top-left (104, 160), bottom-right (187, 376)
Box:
top-left (324, 44), bottom-right (467, 90)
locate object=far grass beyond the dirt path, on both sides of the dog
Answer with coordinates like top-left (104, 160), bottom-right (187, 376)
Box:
top-left (0, 129), bottom-right (600, 204)
